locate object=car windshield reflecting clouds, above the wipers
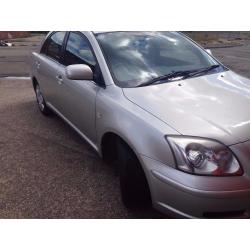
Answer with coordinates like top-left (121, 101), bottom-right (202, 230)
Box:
top-left (95, 32), bottom-right (222, 88)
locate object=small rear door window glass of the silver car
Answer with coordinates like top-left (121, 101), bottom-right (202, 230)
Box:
top-left (44, 32), bottom-right (66, 61)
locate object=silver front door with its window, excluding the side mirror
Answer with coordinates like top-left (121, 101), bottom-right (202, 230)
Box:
top-left (55, 32), bottom-right (102, 143)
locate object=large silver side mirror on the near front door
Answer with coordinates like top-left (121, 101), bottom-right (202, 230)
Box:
top-left (66, 64), bottom-right (93, 81)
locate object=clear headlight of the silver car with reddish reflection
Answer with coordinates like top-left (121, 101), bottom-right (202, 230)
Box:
top-left (166, 136), bottom-right (243, 176)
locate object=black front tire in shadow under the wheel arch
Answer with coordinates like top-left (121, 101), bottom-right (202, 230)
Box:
top-left (117, 141), bottom-right (151, 209)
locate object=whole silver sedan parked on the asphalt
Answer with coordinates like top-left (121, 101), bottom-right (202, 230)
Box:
top-left (31, 32), bottom-right (250, 218)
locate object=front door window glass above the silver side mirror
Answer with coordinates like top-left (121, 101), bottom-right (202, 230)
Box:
top-left (64, 32), bottom-right (96, 69)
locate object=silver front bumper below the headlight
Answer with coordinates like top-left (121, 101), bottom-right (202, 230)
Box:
top-left (142, 156), bottom-right (250, 218)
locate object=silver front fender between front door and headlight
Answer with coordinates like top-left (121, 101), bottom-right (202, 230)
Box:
top-left (96, 85), bottom-right (178, 169)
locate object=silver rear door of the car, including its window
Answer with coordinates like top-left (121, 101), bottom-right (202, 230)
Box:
top-left (35, 31), bottom-right (66, 108)
